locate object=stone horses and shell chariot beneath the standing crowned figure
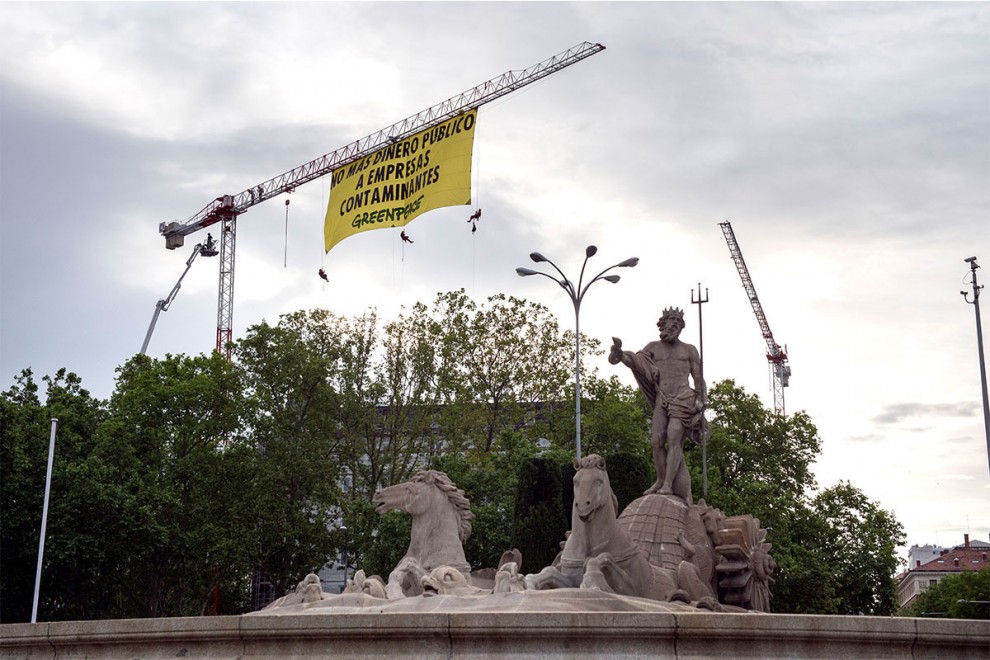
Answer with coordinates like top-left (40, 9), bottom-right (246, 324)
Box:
top-left (266, 454), bottom-right (776, 611)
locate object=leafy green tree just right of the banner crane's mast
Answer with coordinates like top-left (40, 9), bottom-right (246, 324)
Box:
top-left (234, 310), bottom-right (370, 595)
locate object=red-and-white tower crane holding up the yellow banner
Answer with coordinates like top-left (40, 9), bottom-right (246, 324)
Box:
top-left (158, 41), bottom-right (605, 359)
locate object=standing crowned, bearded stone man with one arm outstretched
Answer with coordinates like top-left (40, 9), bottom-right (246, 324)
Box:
top-left (608, 307), bottom-right (708, 503)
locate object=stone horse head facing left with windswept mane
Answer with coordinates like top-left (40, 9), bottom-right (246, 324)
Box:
top-left (373, 470), bottom-right (474, 576)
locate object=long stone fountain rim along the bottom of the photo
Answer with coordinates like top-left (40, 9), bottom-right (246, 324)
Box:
top-left (0, 609), bottom-right (990, 660)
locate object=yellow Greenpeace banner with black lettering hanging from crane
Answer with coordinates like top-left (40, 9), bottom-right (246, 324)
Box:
top-left (323, 110), bottom-right (478, 252)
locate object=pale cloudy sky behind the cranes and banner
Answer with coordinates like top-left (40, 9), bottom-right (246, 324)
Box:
top-left (0, 2), bottom-right (990, 560)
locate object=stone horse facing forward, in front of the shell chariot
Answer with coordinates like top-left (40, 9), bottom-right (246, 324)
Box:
top-left (526, 454), bottom-right (718, 609)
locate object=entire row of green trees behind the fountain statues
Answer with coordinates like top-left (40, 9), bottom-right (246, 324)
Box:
top-left (0, 290), bottom-right (902, 623)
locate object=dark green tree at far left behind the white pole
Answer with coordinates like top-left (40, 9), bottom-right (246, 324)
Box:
top-left (0, 369), bottom-right (120, 622)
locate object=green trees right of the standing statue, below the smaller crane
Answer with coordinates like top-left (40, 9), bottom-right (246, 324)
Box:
top-left (685, 380), bottom-right (903, 615)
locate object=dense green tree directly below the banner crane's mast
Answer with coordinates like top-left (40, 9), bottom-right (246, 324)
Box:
top-left (95, 353), bottom-right (253, 617)
